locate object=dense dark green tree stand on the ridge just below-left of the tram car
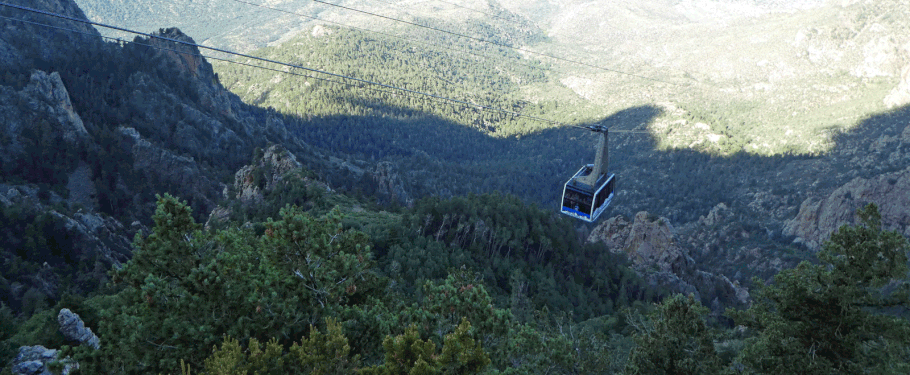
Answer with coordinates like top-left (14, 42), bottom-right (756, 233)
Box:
top-left (396, 194), bottom-right (661, 322)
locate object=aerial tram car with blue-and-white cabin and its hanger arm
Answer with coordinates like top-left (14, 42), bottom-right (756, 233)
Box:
top-left (560, 125), bottom-right (616, 223)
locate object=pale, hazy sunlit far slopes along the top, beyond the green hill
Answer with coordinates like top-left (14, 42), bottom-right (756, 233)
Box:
top-left (80, 0), bottom-right (910, 155)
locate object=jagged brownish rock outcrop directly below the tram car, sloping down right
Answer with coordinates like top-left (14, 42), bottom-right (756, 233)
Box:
top-left (588, 211), bottom-right (749, 313)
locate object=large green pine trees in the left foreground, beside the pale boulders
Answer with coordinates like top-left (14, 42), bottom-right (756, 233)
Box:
top-left (84, 195), bottom-right (381, 372)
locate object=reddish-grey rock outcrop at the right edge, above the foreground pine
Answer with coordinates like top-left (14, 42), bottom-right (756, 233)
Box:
top-left (784, 167), bottom-right (910, 250)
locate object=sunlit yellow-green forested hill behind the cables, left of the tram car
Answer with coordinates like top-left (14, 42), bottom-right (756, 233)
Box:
top-left (215, 26), bottom-right (548, 135)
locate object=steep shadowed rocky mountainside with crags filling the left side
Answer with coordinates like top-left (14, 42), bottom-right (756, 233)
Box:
top-left (0, 0), bottom-right (407, 324)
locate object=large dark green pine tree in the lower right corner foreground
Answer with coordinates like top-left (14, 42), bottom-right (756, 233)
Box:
top-left (728, 204), bottom-right (910, 374)
